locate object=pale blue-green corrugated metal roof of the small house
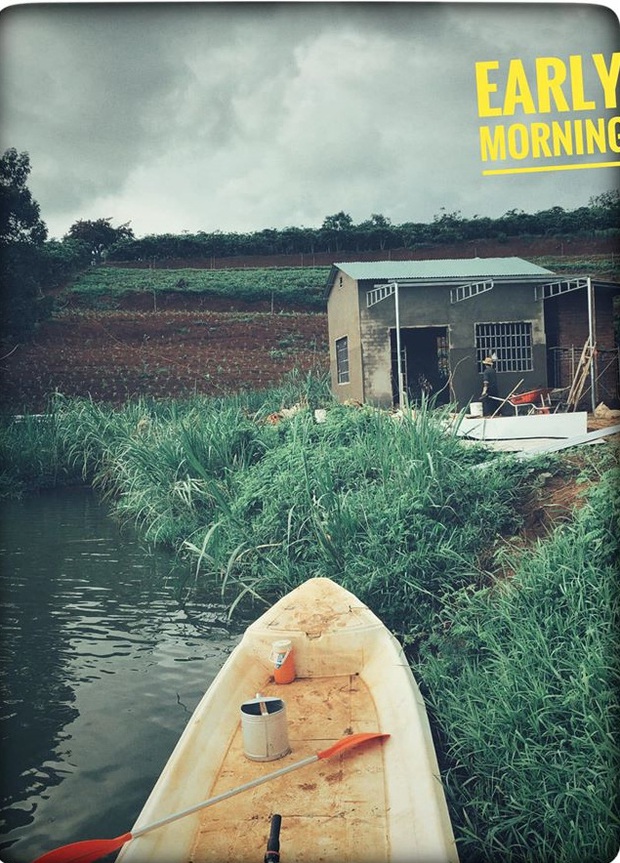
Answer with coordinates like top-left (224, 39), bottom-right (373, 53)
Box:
top-left (332, 258), bottom-right (554, 281)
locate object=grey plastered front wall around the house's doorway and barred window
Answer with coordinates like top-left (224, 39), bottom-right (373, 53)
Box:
top-left (358, 282), bottom-right (547, 407)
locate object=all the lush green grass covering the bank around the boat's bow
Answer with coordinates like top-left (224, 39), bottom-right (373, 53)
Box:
top-left (2, 384), bottom-right (620, 863)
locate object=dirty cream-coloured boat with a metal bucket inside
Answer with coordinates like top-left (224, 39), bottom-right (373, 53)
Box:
top-left (117, 578), bottom-right (458, 863)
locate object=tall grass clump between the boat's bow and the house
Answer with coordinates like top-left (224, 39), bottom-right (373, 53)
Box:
top-left (186, 405), bottom-right (516, 638)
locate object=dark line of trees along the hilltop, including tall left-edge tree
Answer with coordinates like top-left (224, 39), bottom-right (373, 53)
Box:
top-left (0, 148), bottom-right (620, 339)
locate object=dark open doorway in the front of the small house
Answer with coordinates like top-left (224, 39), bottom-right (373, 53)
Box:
top-left (390, 327), bottom-right (450, 404)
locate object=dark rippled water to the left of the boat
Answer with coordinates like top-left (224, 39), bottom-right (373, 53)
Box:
top-left (0, 489), bottom-right (239, 863)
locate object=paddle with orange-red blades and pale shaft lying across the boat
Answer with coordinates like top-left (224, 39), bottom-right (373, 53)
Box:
top-left (34, 731), bottom-right (390, 863)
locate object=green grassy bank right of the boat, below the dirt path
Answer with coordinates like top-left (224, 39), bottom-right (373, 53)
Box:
top-left (418, 468), bottom-right (620, 863)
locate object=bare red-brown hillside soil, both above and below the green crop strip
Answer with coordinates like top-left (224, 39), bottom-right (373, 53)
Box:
top-left (0, 237), bottom-right (617, 412)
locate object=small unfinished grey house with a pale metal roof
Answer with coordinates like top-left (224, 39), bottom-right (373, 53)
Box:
top-left (326, 257), bottom-right (620, 407)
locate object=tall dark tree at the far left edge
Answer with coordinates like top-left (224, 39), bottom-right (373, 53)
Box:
top-left (0, 148), bottom-right (52, 339)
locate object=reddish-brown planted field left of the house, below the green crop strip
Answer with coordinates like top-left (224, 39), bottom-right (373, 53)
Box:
top-left (2, 310), bottom-right (328, 413)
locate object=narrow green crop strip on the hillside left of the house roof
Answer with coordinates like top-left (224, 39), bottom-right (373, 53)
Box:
top-left (64, 267), bottom-right (329, 309)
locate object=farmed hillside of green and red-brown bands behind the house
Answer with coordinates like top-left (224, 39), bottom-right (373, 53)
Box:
top-left (2, 237), bottom-right (620, 412)
